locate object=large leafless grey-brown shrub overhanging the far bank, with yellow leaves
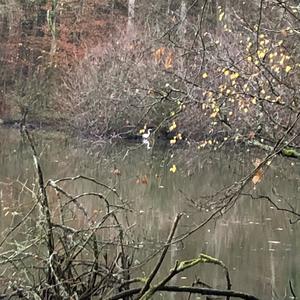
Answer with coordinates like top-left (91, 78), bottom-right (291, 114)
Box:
top-left (59, 1), bottom-right (299, 146)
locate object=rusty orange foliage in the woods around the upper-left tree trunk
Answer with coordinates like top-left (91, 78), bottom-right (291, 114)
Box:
top-left (0, 0), bottom-right (126, 74)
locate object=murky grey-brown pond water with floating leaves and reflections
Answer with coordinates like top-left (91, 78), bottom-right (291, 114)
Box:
top-left (0, 129), bottom-right (300, 299)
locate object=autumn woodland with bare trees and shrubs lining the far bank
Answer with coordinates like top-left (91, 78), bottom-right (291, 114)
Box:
top-left (0, 0), bottom-right (300, 147)
